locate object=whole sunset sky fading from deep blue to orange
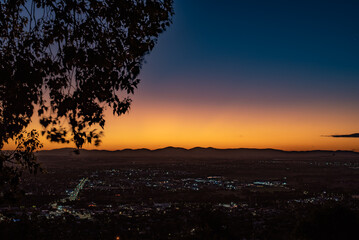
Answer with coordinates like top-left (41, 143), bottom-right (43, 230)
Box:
top-left (8, 0), bottom-right (359, 151)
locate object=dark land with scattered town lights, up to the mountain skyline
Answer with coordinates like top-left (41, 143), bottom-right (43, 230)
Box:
top-left (4, 147), bottom-right (359, 239)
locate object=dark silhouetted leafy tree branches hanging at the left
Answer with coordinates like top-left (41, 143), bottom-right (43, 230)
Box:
top-left (0, 0), bottom-right (173, 195)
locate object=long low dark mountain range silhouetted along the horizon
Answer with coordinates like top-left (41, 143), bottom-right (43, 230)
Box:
top-left (37, 147), bottom-right (359, 159)
